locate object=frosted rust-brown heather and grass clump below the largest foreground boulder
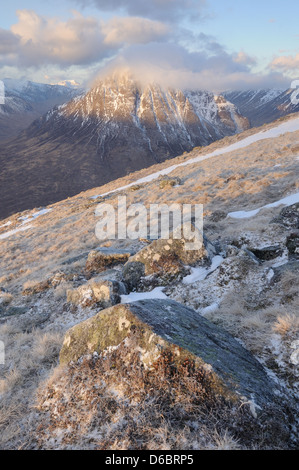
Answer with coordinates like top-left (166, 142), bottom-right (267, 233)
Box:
top-left (35, 344), bottom-right (287, 450)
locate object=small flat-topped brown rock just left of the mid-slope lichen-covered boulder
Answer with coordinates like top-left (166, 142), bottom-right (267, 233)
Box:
top-left (85, 248), bottom-right (131, 273)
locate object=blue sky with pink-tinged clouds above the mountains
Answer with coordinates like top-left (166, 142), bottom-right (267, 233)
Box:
top-left (0, 0), bottom-right (299, 92)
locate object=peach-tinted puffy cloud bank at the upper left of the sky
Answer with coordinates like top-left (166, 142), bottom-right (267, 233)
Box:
top-left (0, 10), bottom-right (170, 67)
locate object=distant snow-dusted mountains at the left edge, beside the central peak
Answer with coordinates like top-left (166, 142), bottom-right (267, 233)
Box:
top-left (0, 78), bottom-right (82, 142)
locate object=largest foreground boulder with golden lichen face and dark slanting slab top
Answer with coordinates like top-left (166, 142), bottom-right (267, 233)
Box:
top-left (60, 299), bottom-right (282, 407)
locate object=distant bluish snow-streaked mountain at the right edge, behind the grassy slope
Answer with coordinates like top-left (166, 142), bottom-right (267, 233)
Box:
top-left (223, 89), bottom-right (299, 127)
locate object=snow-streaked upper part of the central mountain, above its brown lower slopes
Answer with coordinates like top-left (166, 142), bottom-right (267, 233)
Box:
top-left (28, 71), bottom-right (249, 159)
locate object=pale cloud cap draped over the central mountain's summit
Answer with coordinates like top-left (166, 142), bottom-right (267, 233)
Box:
top-left (91, 43), bottom-right (289, 92)
